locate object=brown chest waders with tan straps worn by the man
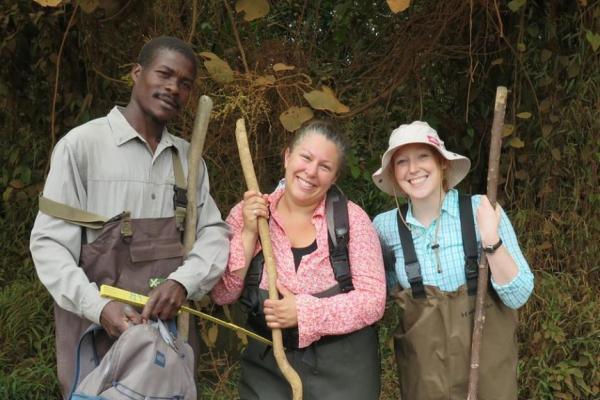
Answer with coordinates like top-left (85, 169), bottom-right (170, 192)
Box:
top-left (40, 150), bottom-right (200, 395)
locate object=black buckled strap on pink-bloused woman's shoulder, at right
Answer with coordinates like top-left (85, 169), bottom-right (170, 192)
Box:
top-left (325, 185), bottom-right (354, 293)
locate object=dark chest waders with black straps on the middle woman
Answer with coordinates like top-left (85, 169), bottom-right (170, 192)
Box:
top-left (239, 186), bottom-right (381, 400)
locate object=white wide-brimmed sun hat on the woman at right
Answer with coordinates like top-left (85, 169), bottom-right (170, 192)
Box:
top-left (373, 121), bottom-right (471, 196)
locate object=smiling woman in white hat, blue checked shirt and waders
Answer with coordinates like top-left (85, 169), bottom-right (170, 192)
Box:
top-left (373, 121), bottom-right (533, 400)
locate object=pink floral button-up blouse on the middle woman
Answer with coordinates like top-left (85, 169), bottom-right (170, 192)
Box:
top-left (212, 189), bottom-right (386, 348)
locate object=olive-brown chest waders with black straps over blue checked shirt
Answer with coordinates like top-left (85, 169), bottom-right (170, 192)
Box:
top-left (394, 195), bottom-right (518, 400)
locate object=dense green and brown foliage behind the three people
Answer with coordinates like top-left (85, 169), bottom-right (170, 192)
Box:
top-left (0, 0), bottom-right (600, 399)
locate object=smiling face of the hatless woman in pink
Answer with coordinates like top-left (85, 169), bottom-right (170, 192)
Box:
top-left (284, 131), bottom-right (340, 206)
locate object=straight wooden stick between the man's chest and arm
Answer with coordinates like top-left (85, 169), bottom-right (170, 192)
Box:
top-left (177, 95), bottom-right (212, 342)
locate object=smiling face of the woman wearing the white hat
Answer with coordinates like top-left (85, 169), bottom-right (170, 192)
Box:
top-left (392, 143), bottom-right (446, 201)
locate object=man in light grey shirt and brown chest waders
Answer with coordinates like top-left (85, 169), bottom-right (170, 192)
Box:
top-left (30, 37), bottom-right (229, 395)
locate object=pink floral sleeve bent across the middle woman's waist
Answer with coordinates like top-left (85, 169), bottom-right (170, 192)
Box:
top-left (296, 203), bottom-right (386, 348)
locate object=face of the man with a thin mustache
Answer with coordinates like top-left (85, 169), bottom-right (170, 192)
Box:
top-left (131, 49), bottom-right (196, 124)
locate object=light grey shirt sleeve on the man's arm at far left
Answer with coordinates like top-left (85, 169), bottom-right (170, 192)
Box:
top-left (30, 139), bottom-right (109, 323)
